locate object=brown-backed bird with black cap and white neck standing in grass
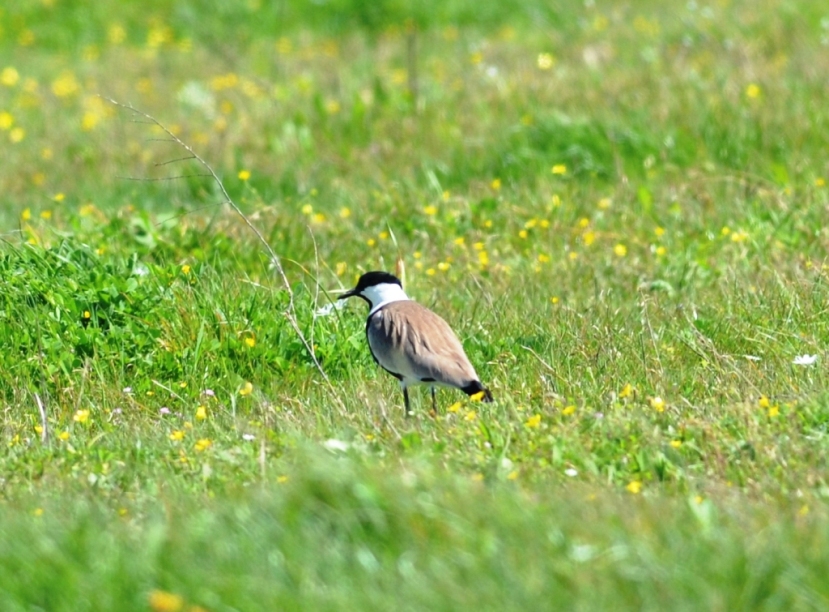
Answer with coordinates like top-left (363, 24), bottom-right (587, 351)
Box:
top-left (338, 270), bottom-right (492, 416)
